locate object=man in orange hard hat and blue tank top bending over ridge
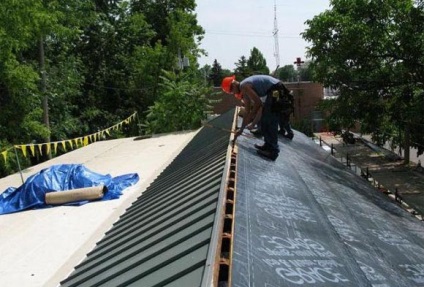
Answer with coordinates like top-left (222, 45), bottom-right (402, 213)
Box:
top-left (221, 75), bottom-right (290, 160)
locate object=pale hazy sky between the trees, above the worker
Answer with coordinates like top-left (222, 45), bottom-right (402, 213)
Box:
top-left (195, 0), bottom-right (330, 71)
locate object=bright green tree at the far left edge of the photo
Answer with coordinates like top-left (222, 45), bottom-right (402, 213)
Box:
top-left (0, 0), bottom-right (86, 146)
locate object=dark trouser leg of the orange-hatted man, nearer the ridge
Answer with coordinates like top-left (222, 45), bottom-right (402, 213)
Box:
top-left (261, 96), bottom-right (280, 154)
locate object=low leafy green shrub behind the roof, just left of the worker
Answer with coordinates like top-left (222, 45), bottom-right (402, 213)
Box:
top-left (145, 72), bottom-right (210, 133)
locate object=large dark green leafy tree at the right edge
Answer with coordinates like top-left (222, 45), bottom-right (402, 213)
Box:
top-left (303, 0), bottom-right (424, 162)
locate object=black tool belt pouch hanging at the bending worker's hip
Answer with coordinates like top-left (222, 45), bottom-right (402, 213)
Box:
top-left (267, 82), bottom-right (294, 114)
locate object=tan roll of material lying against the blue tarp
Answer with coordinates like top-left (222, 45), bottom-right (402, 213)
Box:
top-left (45, 185), bottom-right (107, 204)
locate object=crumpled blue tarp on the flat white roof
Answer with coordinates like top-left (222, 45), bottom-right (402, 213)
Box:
top-left (0, 164), bottom-right (139, 214)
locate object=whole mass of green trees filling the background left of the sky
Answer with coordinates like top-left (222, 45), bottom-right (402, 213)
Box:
top-left (0, 0), bottom-right (208, 178)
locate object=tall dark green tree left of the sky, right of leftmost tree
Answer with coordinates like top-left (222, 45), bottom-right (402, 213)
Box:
top-left (70, 0), bottom-right (203, 130)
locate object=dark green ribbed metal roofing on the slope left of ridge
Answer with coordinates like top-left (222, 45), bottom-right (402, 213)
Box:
top-left (61, 110), bottom-right (234, 287)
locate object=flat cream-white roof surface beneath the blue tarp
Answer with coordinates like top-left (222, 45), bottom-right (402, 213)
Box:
top-left (0, 131), bottom-right (197, 287)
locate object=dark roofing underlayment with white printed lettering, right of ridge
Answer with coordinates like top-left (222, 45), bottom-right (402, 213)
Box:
top-left (232, 129), bottom-right (424, 287)
